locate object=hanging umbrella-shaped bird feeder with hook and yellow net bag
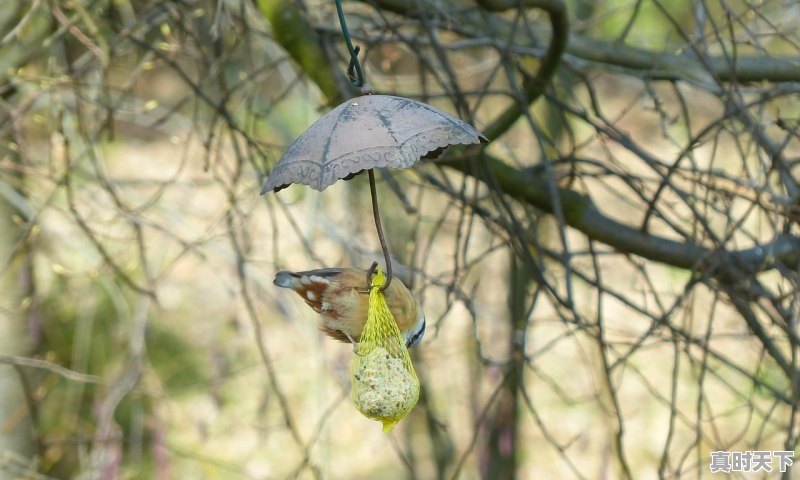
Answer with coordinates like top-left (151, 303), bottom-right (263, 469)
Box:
top-left (261, 0), bottom-right (488, 431)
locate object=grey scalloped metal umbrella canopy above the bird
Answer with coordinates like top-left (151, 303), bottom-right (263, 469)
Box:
top-left (261, 95), bottom-right (487, 194)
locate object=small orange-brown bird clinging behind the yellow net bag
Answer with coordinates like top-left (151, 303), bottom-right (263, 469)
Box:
top-left (273, 268), bottom-right (425, 347)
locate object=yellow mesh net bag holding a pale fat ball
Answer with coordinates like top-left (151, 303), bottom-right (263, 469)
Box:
top-left (350, 267), bottom-right (419, 432)
